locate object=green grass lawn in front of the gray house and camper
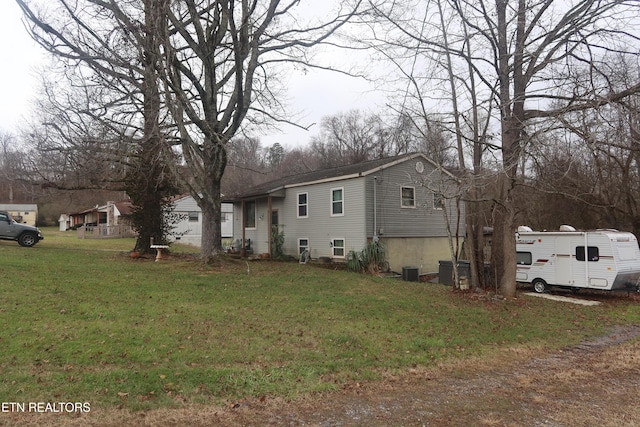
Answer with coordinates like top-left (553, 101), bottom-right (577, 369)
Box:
top-left (0, 230), bottom-right (640, 410)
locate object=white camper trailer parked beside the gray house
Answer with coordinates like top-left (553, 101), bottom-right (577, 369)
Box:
top-left (516, 226), bottom-right (640, 293)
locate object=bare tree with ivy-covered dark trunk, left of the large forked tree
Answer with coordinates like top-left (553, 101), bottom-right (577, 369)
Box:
top-left (16, 0), bottom-right (180, 252)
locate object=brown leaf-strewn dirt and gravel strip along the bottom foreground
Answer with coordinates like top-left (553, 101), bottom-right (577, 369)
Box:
top-left (7, 325), bottom-right (640, 427)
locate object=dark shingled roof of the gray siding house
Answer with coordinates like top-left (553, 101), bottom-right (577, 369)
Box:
top-left (226, 153), bottom-right (448, 201)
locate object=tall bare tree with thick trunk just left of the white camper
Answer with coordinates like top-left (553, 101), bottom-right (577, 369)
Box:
top-left (362, 0), bottom-right (640, 297)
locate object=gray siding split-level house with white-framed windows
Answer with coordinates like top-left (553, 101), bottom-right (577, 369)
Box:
top-left (227, 153), bottom-right (465, 272)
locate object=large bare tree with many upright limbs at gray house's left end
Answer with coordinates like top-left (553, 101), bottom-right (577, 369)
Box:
top-left (154, 0), bottom-right (359, 262)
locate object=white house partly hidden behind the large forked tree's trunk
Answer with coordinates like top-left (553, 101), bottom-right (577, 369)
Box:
top-left (170, 196), bottom-right (233, 246)
